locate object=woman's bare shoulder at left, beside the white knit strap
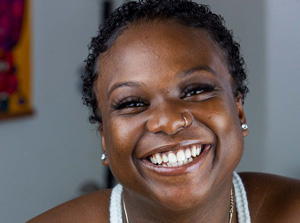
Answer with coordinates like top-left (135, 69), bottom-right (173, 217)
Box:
top-left (27, 190), bottom-right (111, 223)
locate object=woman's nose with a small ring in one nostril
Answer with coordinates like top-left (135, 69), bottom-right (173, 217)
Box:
top-left (146, 103), bottom-right (193, 135)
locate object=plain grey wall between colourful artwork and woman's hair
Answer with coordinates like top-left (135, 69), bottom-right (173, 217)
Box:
top-left (0, 0), bottom-right (103, 222)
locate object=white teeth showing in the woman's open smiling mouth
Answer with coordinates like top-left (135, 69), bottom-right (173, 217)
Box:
top-left (146, 144), bottom-right (211, 167)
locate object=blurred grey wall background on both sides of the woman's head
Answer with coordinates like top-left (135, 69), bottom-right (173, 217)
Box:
top-left (0, 0), bottom-right (300, 222)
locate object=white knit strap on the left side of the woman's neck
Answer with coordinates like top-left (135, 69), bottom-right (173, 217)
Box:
top-left (109, 184), bottom-right (123, 223)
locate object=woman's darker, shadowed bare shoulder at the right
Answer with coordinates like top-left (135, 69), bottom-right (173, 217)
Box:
top-left (239, 173), bottom-right (300, 223)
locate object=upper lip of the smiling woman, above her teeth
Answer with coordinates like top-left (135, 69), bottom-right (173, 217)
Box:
top-left (140, 140), bottom-right (212, 159)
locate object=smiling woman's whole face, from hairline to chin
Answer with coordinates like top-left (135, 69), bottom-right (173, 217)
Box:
top-left (96, 21), bottom-right (247, 209)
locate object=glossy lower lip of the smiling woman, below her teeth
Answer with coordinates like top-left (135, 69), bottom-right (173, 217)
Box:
top-left (141, 143), bottom-right (214, 176)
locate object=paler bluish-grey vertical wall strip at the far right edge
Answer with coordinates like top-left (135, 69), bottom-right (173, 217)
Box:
top-left (265, 0), bottom-right (300, 178)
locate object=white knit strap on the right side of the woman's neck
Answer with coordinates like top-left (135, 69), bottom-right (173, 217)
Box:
top-left (232, 172), bottom-right (251, 223)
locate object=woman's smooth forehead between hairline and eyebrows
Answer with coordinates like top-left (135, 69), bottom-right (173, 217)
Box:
top-left (98, 20), bottom-right (228, 96)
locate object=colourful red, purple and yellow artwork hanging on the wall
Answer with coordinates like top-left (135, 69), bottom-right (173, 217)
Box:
top-left (0, 0), bottom-right (32, 120)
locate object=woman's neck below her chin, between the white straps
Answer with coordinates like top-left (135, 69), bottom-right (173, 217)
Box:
top-left (123, 176), bottom-right (237, 223)
